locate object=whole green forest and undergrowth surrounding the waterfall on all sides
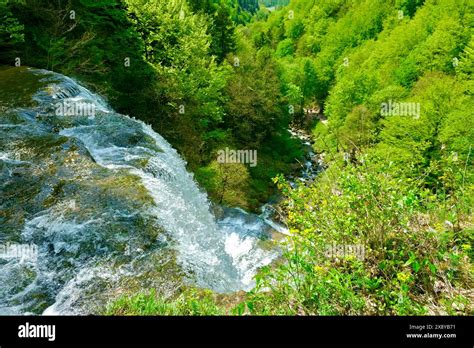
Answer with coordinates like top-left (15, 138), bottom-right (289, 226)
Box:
top-left (0, 0), bottom-right (474, 315)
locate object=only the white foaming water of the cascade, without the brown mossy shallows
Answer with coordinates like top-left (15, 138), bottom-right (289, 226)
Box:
top-left (0, 70), bottom-right (277, 314)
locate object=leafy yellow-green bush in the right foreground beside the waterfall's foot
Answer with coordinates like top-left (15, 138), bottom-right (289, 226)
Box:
top-left (245, 158), bottom-right (473, 315)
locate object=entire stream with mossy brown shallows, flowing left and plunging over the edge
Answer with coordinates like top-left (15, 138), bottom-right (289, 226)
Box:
top-left (0, 68), bottom-right (285, 314)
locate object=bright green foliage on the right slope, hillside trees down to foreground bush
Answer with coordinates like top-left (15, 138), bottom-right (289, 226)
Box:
top-left (231, 0), bottom-right (474, 315)
